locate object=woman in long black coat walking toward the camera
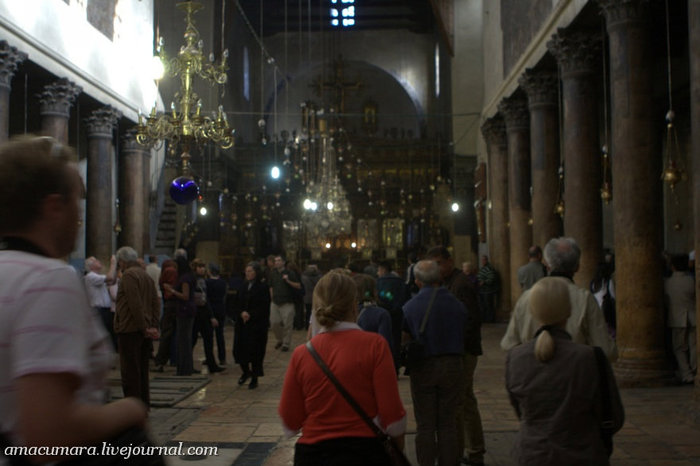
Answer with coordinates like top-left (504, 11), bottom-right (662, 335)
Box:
top-left (233, 262), bottom-right (270, 389)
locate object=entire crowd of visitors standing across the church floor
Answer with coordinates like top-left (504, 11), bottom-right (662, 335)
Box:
top-left (0, 133), bottom-right (697, 466)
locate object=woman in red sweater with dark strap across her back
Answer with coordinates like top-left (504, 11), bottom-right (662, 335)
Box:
top-left (279, 272), bottom-right (406, 466)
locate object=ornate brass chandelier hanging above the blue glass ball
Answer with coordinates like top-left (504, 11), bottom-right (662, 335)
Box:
top-left (136, 1), bottom-right (235, 181)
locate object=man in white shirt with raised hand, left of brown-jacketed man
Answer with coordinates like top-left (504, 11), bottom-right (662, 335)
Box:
top-left (83, 256), bottom-right (117, 349)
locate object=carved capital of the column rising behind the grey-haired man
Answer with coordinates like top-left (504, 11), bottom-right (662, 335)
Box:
top-left (547, 28), bottom-right (601, 75)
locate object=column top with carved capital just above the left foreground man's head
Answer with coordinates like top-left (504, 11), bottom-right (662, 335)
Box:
top-left (38, 78), bottom-right (83, 144)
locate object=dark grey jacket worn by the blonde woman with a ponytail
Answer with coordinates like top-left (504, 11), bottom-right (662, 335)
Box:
top-left (506, 329), bottom-right (625, 466)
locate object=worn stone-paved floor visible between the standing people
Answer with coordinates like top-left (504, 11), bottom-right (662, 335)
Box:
top-left (144, 324), bottom-right (700, 466)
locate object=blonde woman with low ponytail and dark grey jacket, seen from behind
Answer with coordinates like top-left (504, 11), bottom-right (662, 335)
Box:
top-left (506, 277), bottom-right (625, 466)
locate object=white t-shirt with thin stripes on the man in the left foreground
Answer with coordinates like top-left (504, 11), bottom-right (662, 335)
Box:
top-left (0, 251), bottom-right (113, 444)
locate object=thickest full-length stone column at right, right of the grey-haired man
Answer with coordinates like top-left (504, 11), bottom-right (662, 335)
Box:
top-left (599, 0), bottom-right (670, 386)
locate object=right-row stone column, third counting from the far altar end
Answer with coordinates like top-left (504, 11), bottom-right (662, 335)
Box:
top-left (518, 70), bottom-right (562, 247)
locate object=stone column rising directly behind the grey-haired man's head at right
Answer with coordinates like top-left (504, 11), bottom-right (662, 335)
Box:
top-left (547, 29), bottom-right (603, 288)
